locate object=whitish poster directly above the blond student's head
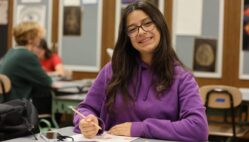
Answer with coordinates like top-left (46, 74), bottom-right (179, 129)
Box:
top-left (16, 5), bottom-right (46, 27)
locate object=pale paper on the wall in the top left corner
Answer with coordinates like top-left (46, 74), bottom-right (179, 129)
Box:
top-left (0, 0), bottom-right (8, 25)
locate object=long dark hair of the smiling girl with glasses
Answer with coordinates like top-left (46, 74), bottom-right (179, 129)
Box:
top-left (106, 1), bottom-right (183, 111)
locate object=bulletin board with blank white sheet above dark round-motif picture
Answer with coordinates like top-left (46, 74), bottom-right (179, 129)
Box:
top-left (173, 0), bottom-right (224, 78)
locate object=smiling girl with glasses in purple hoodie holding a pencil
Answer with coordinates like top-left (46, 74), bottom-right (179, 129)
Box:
top-left (74, 0), bottom-right (208, 141)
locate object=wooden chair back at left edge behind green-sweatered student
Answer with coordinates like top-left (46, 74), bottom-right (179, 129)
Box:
top-left (0, 74), bottom-right (11, 102)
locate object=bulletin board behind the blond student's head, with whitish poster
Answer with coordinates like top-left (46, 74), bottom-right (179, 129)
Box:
top-left (13, 0), bottom-right (52, 48)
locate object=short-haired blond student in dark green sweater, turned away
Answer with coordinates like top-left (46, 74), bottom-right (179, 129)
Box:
top-left (0, 22), bottom-right (52, 106)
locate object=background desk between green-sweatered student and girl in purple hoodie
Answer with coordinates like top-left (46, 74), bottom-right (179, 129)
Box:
top-left (52, 80), bottom-right (92, 128)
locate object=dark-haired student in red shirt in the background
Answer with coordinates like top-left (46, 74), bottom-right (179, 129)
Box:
top-left (35, 39), bottom-right (65, 77)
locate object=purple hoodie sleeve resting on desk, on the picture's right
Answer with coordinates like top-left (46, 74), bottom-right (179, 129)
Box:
top-left (131, 73), bottom-right (208, 141)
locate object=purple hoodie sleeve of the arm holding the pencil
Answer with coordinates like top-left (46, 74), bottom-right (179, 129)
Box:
top-left (73, 64), bottom-right (110, 133)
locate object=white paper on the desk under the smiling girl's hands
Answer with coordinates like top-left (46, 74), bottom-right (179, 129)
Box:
top-left (69, 133), bottom-right (137, 142)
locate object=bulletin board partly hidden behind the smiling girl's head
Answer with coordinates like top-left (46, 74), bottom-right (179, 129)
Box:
top-left (115, 0), bottom-right (165, 41)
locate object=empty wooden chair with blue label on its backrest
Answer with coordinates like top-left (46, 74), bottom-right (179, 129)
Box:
top-left (200, 85), bottom-right (249, 140)
